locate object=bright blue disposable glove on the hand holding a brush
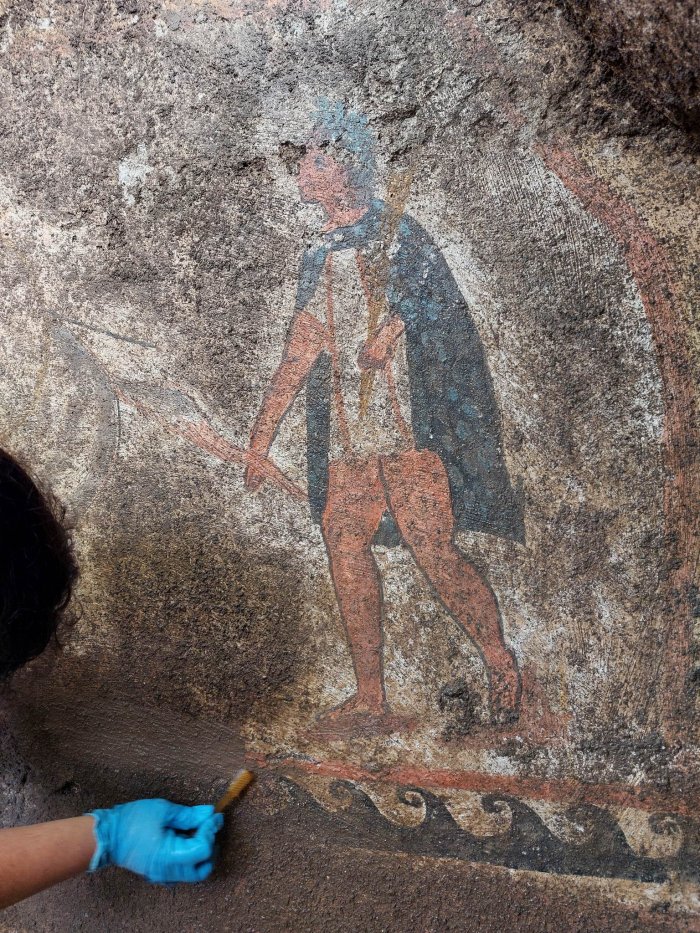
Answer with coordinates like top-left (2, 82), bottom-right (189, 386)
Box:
top-left (88, 800), bottom-right (224, 884)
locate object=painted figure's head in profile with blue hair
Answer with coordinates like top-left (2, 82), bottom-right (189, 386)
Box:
top-left (298, 98), bottom-right (377, 219)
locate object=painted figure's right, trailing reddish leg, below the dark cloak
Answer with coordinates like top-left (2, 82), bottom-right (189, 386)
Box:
top-left (382, 450), bottom-right (520, 722)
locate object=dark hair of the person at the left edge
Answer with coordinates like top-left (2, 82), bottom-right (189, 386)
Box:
top-left (0, 449), bottom-right (78, 680)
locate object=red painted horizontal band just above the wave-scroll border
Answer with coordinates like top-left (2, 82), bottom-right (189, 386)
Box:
top-left (249, 756), bottom-right (700, 817)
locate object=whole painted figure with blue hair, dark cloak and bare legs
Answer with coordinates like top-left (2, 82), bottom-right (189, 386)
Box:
top-left (246, 102), bottom-right (523, 723)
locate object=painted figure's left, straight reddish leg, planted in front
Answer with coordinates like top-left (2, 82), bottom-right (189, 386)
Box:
top-left (322, 457), bottom-right (386, 715)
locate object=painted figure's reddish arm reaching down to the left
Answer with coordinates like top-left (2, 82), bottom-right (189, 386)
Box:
top-left (246, 311), bottom-right (328, 488)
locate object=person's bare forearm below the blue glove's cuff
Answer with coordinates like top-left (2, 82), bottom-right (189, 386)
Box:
top-left (0, 816), bottom-right (95, 909)
